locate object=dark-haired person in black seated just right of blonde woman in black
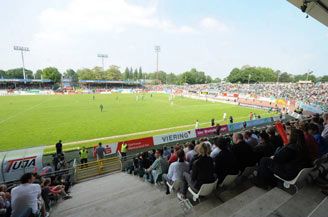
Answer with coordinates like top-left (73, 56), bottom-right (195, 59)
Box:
top-left (214, 137), bottom-right (239, 184)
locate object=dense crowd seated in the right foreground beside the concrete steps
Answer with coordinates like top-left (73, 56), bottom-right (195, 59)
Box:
top-left (128, 113), bottom-right (328, 200)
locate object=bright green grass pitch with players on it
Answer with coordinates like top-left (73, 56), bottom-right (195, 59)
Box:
top-left (0, 94), bottom-right (270, 152)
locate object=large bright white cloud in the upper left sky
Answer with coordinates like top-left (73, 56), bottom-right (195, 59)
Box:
top-left (36, 0), bottom-right (194, 40)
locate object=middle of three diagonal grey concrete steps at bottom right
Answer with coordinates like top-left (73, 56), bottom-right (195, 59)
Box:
top-left (231, 188), bottom-right (292, 217)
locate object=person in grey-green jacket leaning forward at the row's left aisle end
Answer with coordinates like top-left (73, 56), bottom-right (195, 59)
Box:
top-left (146, 149), bottom-right (169, 183)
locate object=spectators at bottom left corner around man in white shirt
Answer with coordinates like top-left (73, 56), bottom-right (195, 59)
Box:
top-left (0, 170), bottom-right (71, 217)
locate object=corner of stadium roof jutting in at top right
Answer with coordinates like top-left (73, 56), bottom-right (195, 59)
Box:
top-left (287, 0), bottom-right (328, 27)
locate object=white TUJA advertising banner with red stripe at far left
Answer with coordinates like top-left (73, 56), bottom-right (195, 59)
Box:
top-left (0, 146), bottom-right (45, 183)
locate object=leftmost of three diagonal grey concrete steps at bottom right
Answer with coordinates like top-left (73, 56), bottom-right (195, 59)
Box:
top-left (200, 187), bottom-right (266, 217)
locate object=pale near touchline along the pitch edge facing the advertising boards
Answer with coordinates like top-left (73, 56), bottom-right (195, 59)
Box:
top-left (46, 113), bottom-right (267, 149)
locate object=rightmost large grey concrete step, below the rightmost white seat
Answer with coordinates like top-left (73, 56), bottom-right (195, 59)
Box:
top-left (268, 185), bottom-right (328, 217)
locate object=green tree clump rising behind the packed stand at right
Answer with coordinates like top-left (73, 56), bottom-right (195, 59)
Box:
top-left (224, 66), bottom-right (328, 84)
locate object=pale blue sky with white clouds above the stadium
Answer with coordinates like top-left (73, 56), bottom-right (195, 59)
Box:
top-left (0, 0), bottom-right (328, 78)
